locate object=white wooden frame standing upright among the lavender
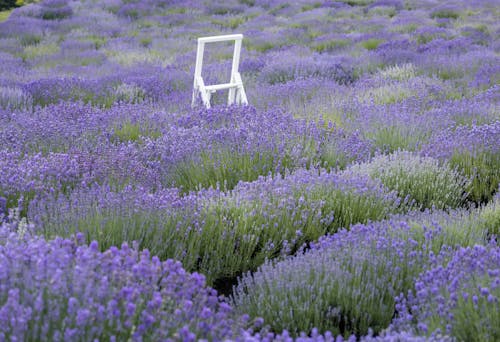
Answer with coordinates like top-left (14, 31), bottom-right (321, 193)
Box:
top-left (191, 34), bottom-right (248, 108)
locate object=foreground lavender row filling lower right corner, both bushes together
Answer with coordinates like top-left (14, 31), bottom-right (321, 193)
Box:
top-left (233, 203), bottom-right (499, 341)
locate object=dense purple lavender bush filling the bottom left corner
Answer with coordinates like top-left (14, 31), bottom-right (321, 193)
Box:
top-left (0, 226), bottom-right (249, 341)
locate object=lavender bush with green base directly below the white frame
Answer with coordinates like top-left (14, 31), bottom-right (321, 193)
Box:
top-left (160, 107), bottom-right (321, 192)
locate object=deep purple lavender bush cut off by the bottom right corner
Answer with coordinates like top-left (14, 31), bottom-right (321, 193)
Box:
top-left (396, 243), bottom-right (500, 341)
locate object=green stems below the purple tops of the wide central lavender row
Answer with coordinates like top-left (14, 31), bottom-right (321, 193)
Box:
top-left (37, 170), bottom-right (395, 285)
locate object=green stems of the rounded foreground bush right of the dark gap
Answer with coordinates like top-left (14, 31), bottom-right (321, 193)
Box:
top-left (234, 245), bottom-right (398, 336)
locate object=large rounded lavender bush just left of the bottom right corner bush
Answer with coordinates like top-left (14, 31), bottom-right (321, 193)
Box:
top-left (233, 214), bottom-right (485, 336)
